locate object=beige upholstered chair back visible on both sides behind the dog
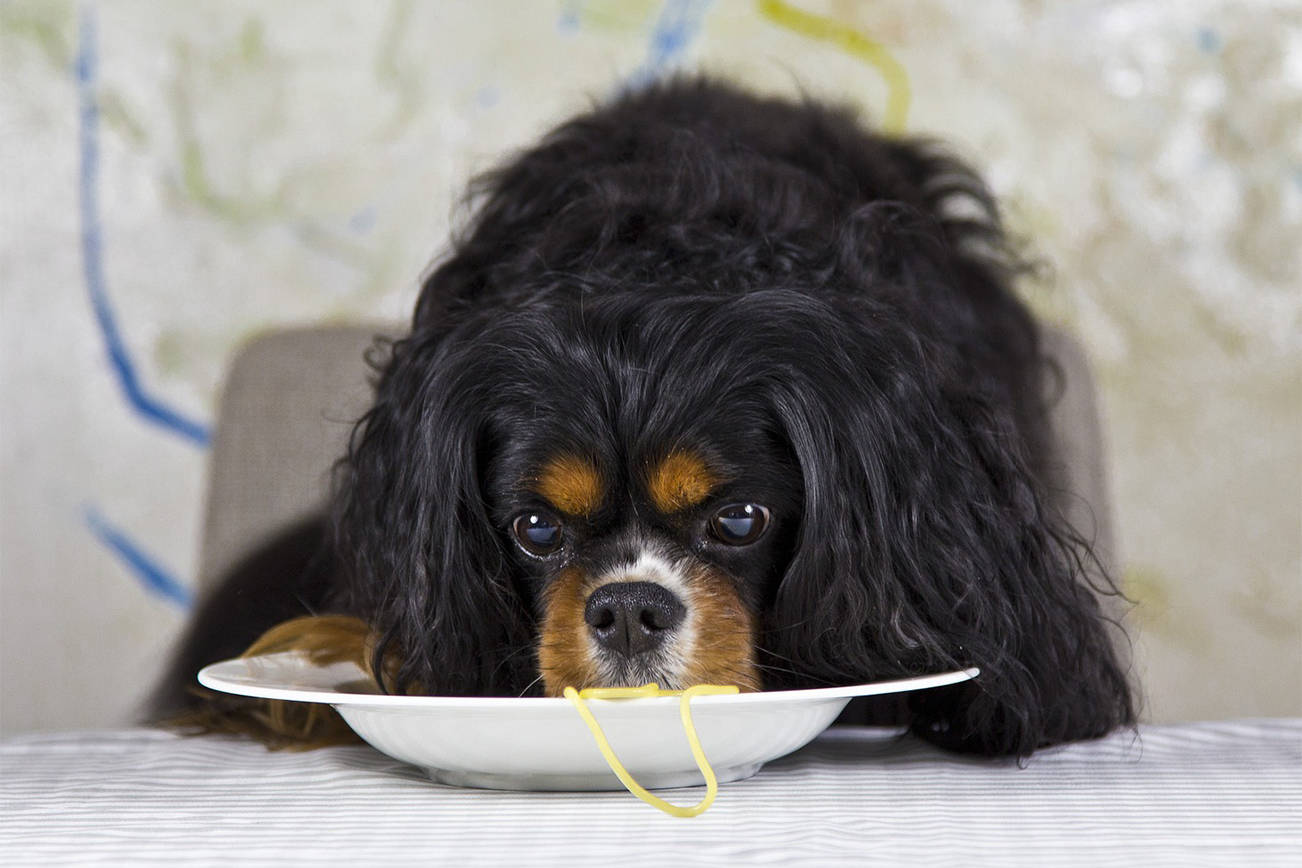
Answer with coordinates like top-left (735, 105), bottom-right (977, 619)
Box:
top-left (199, 324), bottom-right (1116, 592)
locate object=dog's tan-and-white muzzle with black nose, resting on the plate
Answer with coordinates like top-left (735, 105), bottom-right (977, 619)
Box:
top-left (538, 557), bottom-right (760, 696)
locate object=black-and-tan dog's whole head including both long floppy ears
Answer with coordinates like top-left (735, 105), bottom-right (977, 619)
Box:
top-left (341, 290), bottom-right (1130, 750)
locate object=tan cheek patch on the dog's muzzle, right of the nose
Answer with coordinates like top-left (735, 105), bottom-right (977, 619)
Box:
top-left (682, 567), bottom-right (760, 692)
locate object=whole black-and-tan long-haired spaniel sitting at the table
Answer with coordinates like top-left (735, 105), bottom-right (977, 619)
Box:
top-left (155, 78), bottom-right (1135, 756)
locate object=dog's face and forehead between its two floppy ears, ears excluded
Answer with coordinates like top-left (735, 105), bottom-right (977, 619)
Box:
top-left (450, 301), bottom-right (803, 695)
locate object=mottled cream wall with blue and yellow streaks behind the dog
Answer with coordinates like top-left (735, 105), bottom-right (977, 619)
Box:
top-left (0, 0), bottom-right (1302, 733)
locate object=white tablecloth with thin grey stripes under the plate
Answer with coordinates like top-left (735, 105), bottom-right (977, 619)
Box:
top-left (0, 720), bottom-right (1302, 868)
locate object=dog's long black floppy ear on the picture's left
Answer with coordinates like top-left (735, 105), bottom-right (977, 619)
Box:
top-left (336, 324), bottom-right (534, 695)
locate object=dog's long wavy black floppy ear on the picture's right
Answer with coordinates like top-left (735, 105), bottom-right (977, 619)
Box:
top-left (764, 296), bottom-right (1133, 755)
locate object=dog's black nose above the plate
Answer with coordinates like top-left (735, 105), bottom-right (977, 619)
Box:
top-left (583, 582), bottom-right (687, 657)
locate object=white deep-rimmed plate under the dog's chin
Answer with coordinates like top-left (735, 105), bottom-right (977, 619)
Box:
top-left (199, 652), bottom-right (979, 790)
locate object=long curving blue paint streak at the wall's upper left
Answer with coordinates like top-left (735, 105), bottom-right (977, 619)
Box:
top-left (76, 10), bottom-right (211, 446)
